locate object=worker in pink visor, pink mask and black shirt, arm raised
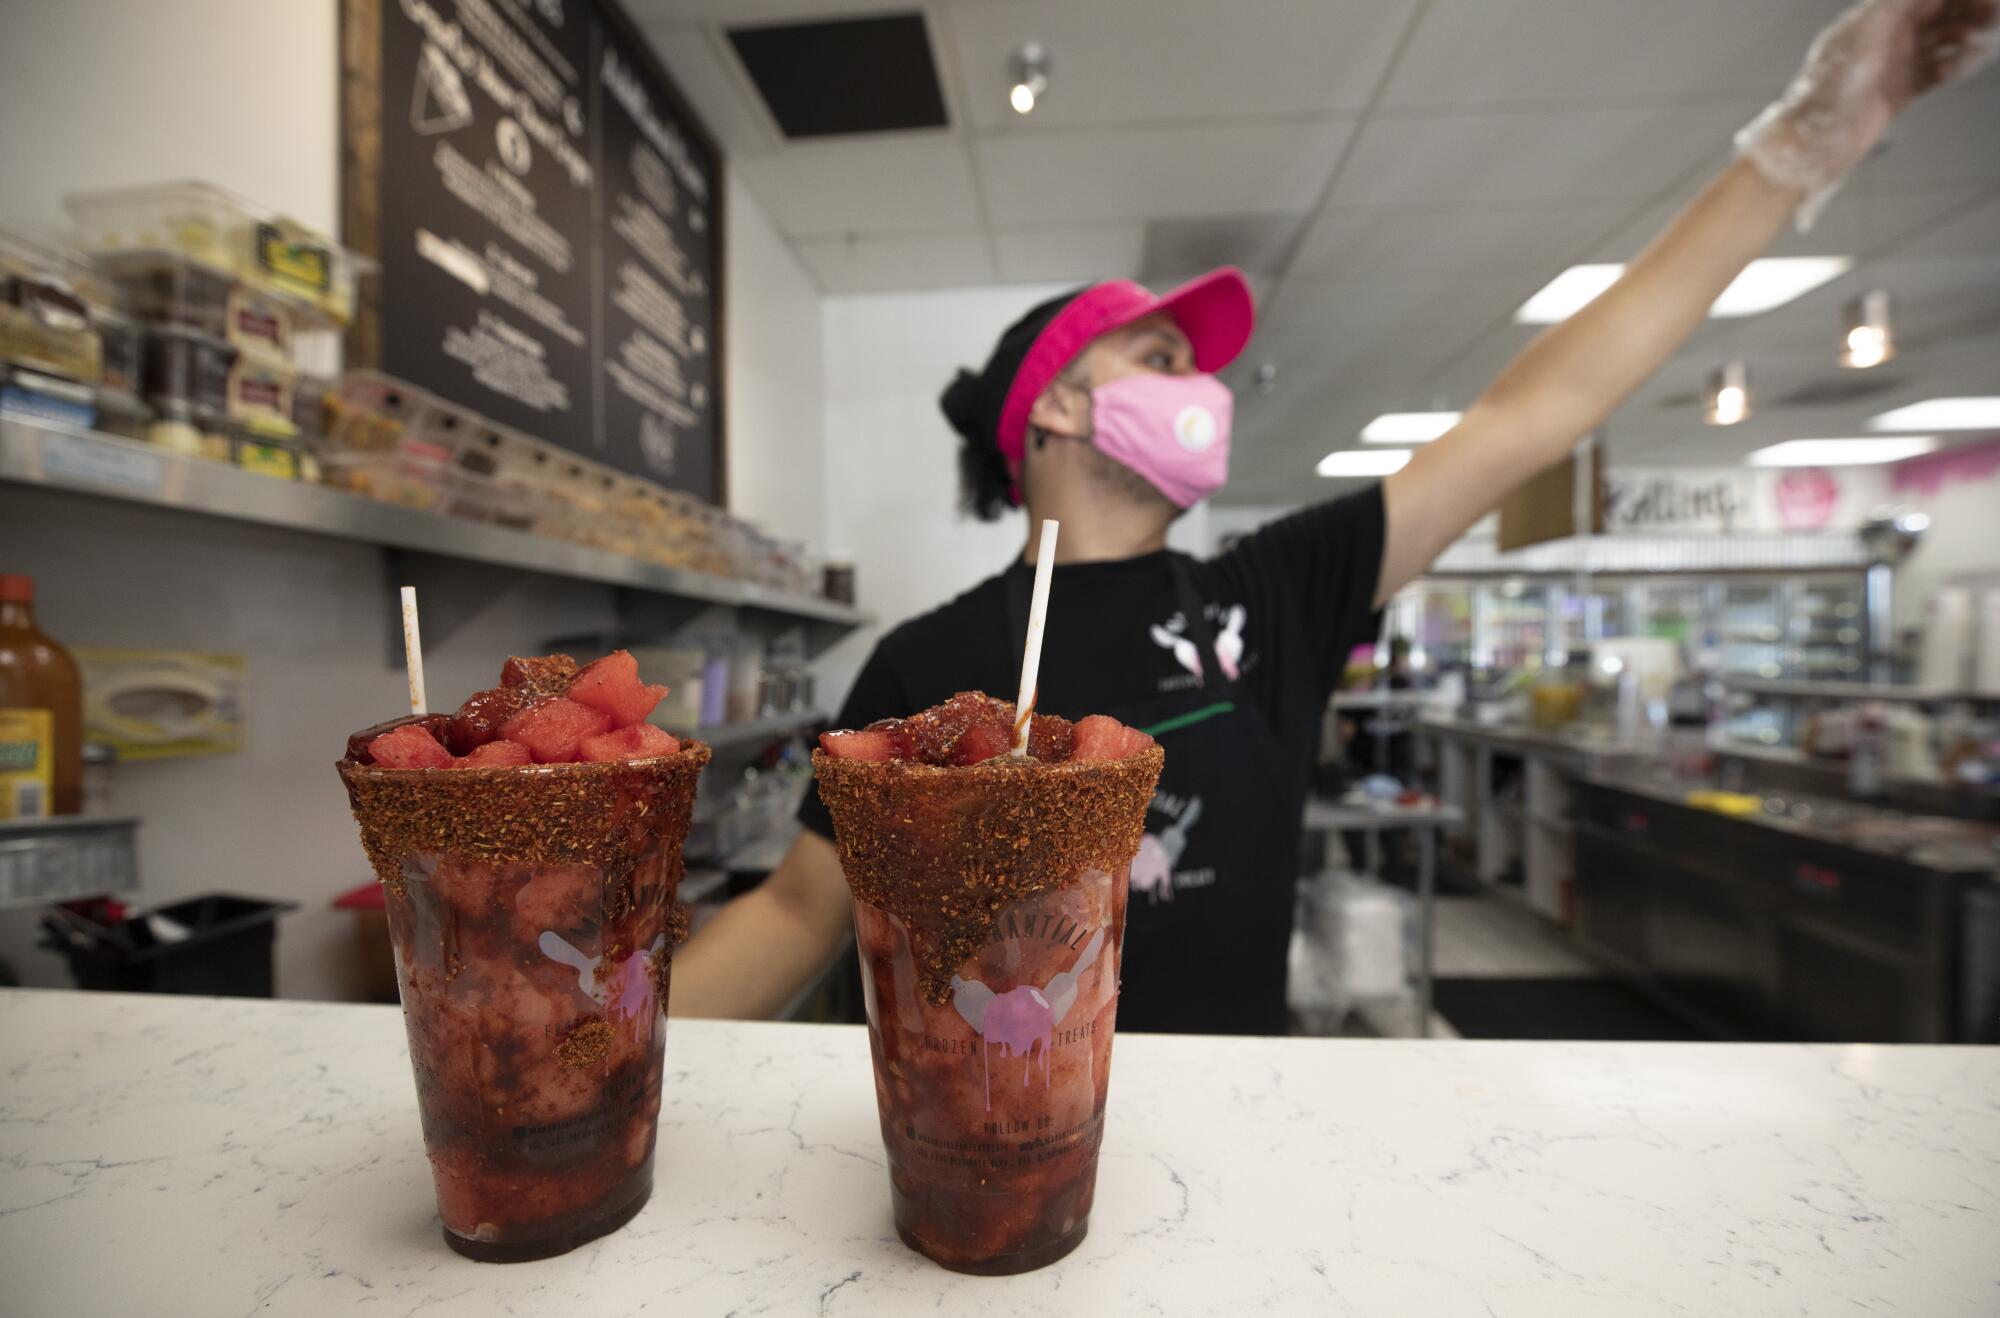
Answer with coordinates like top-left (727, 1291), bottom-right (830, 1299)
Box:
top-left (672, 0), bottom-right (1994, 1034)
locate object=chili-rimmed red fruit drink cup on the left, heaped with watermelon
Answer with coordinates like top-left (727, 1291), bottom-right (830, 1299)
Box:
top-left (338, 652), bottom-right (708, 1262)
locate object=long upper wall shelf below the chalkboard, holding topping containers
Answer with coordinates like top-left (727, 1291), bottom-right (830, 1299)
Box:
top-left (0, 416), bottom-right (874, 630)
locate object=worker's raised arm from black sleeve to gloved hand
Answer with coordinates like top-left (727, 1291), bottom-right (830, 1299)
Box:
top-left (1376, 0), bottom-right (1994, 604)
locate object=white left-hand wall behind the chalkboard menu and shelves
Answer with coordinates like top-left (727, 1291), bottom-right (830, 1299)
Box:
top-left (0, 0), bottom-right (824, 998)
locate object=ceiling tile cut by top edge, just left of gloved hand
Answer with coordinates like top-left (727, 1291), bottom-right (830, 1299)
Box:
top-left (1382, 0), bottom-right (1846, 108)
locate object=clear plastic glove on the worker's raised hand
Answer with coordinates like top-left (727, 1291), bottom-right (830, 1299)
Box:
top-left (1736, 0), bottom-right (2000, 232)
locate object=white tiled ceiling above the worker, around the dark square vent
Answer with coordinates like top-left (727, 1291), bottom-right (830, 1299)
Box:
top-left (626, 0), bottom-right (2000, 504)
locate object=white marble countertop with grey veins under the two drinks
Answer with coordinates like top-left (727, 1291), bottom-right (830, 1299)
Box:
top-left (0, 990), bottom-right (2000, 1318)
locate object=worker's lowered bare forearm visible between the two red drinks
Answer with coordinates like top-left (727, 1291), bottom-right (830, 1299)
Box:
top-left (668, 856), bottom-right (850, 1020)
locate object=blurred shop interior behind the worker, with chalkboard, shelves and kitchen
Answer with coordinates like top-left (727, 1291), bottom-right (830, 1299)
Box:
top-left (0, 0), bottom-right (2000, 1042)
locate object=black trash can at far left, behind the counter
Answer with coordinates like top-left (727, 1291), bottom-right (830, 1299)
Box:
top-left (42, 892), bottom-right (298, 998)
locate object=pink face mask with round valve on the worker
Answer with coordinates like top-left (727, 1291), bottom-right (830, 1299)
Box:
top-left (1090, 372), bottom-right (1236, 508)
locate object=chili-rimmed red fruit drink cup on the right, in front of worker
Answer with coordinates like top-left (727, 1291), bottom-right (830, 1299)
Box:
top-left (812, 694), bottom-right (1164, 1274)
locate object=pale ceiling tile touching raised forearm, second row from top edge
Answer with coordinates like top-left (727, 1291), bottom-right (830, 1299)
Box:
top-left (1330, 104), bottom-right (1756, 210)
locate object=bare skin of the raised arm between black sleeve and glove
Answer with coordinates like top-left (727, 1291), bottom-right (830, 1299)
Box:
top-left (1378, 162), bottom-right (1800, 602)
